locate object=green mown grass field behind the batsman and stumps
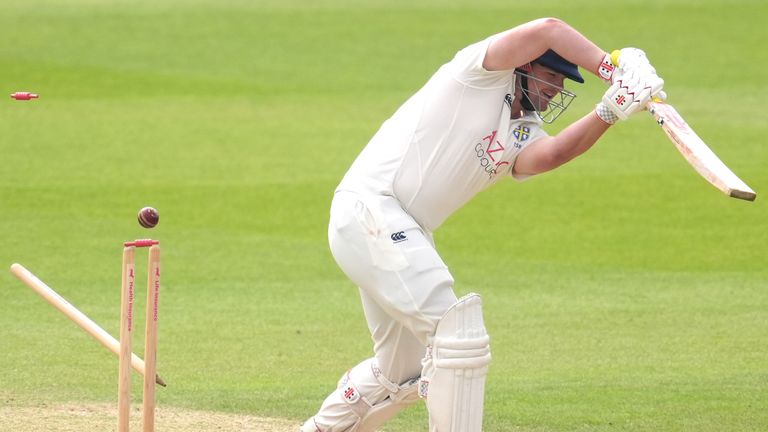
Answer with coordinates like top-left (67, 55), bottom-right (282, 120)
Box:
top-left (0, 0), bottom-right (768, 432)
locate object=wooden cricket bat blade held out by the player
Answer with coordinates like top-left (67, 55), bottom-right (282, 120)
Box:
top-left (648, 100), bottom-right (757, 201)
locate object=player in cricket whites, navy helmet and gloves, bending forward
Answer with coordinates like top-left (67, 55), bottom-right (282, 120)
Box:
top-left (300, 18), bottom-right (664, 432)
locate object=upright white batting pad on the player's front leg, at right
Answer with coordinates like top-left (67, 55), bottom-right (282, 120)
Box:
top-left (419, 293), bottom-right (491, 432)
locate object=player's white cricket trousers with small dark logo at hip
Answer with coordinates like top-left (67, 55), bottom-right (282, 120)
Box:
top-left (314, 191), bottom-right (457, 431)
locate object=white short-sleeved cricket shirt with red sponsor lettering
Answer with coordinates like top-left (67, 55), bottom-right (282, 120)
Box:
top-left (336, 37), bottom-right (546, 231)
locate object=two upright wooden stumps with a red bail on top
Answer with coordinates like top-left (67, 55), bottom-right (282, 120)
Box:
top-left (117, 239), bottom-right (160, 432)
